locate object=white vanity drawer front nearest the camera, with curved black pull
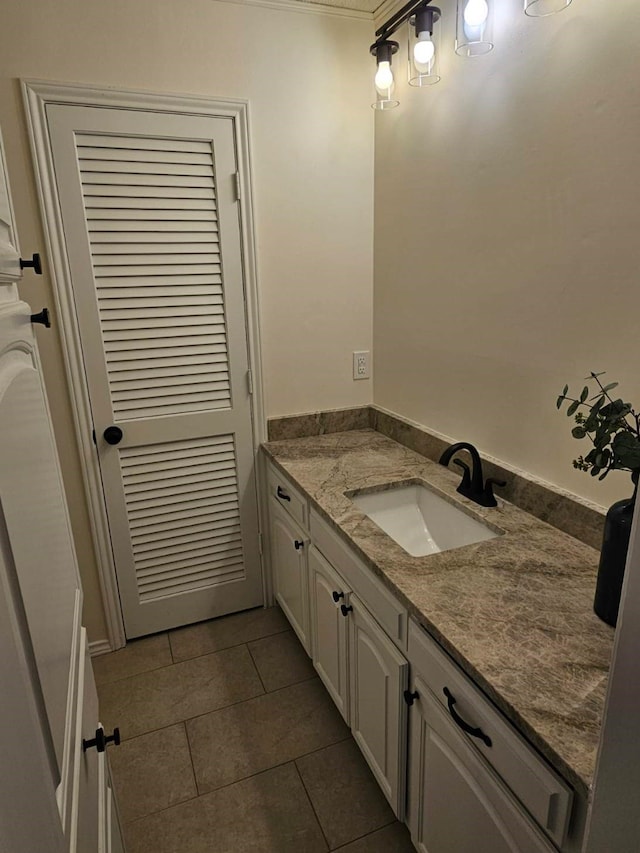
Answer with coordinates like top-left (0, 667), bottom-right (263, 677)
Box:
top-left (408, 619), bottom-right (573, 847)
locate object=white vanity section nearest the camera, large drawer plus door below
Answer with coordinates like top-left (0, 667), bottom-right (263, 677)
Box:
top-left (408, 622), bottom-right (573, 853)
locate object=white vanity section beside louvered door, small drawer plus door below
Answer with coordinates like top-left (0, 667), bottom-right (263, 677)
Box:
top-left (268, 468), bottom-right (311, 655)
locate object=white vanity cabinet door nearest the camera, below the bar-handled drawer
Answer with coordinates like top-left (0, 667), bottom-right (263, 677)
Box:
top-left (409, 678), bottom-right (555, 853)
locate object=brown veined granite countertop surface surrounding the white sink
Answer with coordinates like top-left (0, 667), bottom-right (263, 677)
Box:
top-left (263, 429), bottom-right (614, 796)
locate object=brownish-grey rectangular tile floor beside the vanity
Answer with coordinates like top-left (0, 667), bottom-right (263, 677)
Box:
top-left (93, 607), bottom-right (414, 853)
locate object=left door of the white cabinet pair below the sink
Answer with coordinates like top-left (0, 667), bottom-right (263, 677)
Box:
top-left (309, 547), bottom-right (349, 724)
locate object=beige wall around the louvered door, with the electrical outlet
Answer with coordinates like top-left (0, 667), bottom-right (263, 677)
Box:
top-left (0, 0), bottom-right (373, 641)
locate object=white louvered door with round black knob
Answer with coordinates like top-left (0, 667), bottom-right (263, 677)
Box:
top-left (47, 105), bottom-right (262, 637)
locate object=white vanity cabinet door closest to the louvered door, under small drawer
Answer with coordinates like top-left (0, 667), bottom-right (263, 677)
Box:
top-left (270, 499), bottom-right (311, 654)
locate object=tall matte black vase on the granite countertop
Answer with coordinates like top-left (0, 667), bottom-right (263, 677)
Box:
top-left (593, 471), bottom-right (638, 626)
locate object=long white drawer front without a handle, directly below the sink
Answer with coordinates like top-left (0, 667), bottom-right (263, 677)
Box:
top-left (309, 509), bottom-right (408, 651)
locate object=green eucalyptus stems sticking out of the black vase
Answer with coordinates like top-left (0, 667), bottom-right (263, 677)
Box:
top-left (556, 372), bottom-right (640, 482)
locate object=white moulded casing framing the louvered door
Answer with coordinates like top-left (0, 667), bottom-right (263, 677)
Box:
top-left (21, 79), bottom-right (270, 651)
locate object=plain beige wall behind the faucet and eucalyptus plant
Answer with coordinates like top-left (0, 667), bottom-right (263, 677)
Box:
top-left (374, 0), bottom-right (640, 506)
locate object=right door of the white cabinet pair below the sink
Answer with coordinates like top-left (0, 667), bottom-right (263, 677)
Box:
top-left (349, 595), bottom-right (409, 820)
